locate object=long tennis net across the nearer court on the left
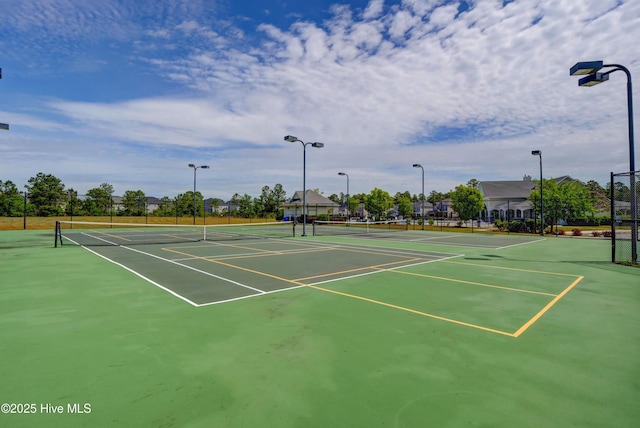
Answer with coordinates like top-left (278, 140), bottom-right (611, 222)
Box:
top-left (55, 220), bottom-right (295, 247)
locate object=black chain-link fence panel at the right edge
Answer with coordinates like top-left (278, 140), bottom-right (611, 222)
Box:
top-left (610, 171), bottom-right (640, 264)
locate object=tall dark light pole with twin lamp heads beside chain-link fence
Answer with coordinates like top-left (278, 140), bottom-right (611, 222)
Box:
top-left (569, 61), bottom-right (638, 263)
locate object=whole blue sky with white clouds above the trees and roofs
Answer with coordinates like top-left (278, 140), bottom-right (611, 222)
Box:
top-left (0, 0), bottom-right (640, 199)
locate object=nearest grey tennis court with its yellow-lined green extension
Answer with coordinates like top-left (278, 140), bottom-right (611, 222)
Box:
top-left (57, 222), bottom-right (583, 337)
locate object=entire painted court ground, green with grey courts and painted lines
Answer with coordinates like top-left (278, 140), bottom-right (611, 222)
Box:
top-left (0, 231), bottom-right (640, 427)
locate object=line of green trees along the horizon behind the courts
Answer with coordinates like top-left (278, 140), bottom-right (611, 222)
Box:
top-left (0, 173), bottom-right (630, 224)
